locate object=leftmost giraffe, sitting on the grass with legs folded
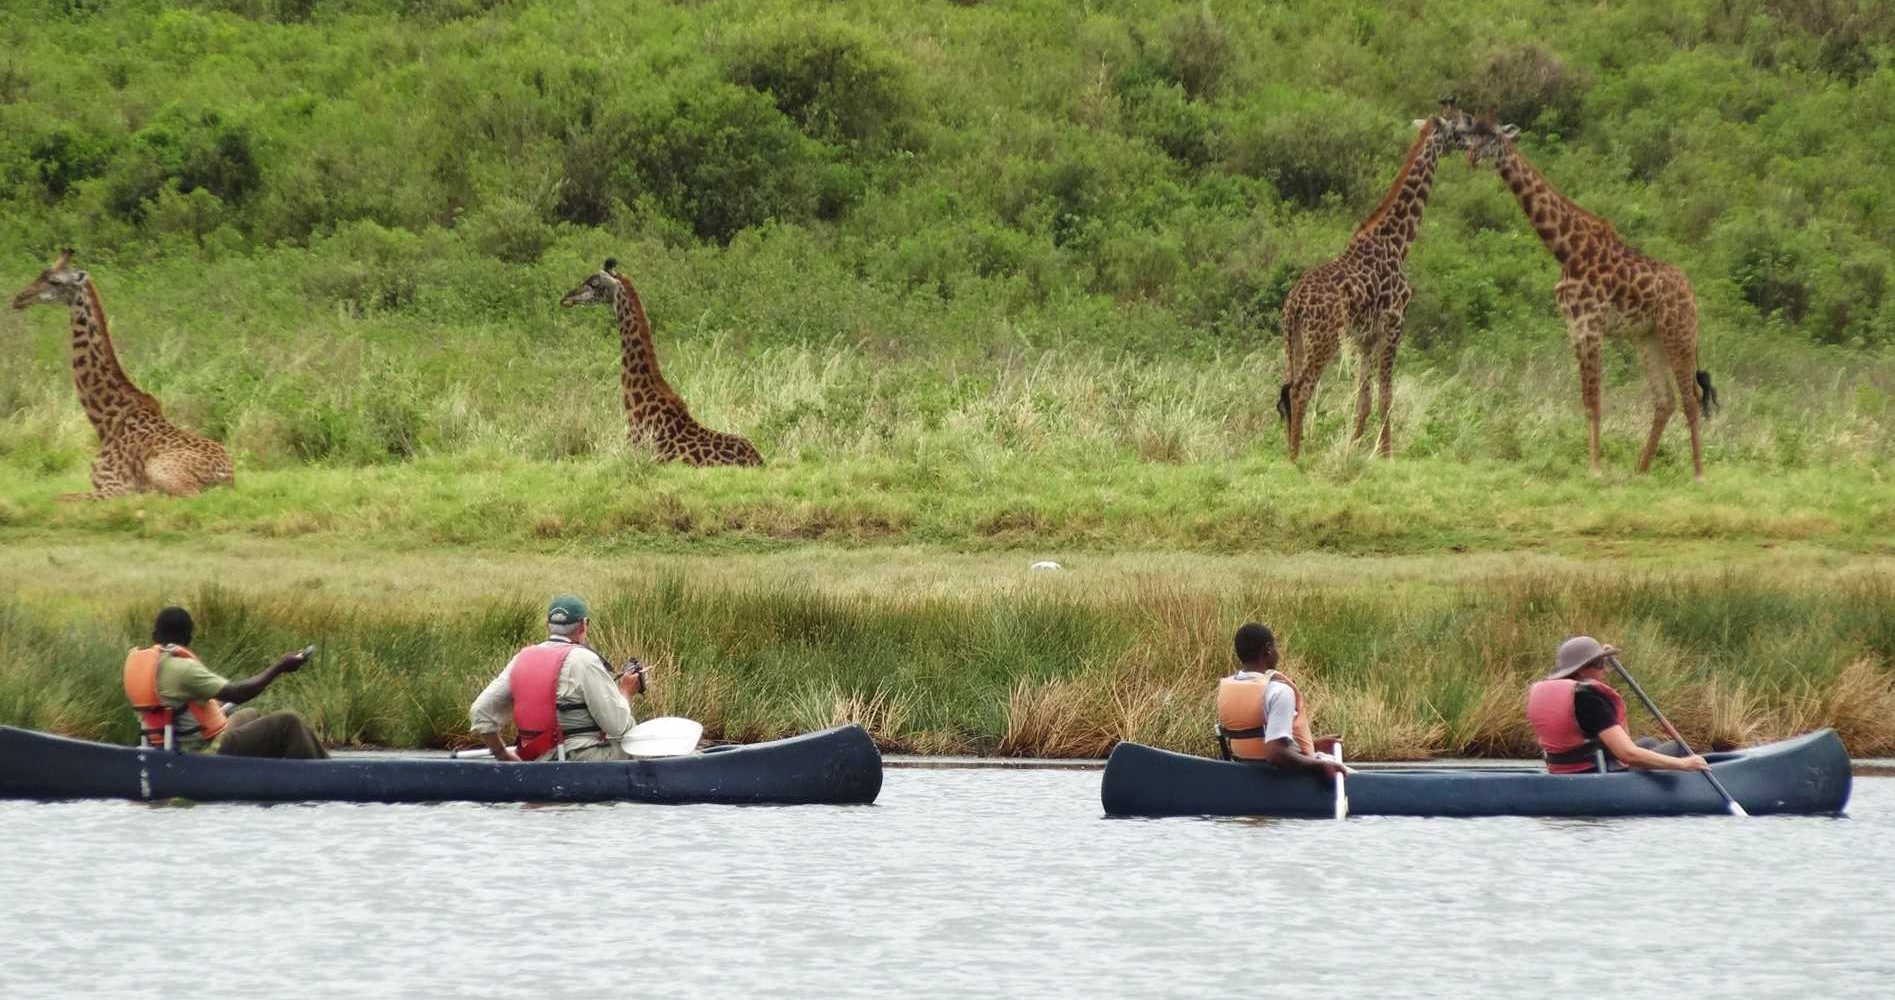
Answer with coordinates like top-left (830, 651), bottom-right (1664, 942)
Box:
top-left (13, 250), bottom-right (235, 500)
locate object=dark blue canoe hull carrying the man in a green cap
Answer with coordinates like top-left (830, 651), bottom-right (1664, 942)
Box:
top-left (0, 725), bottom-right (881, 805)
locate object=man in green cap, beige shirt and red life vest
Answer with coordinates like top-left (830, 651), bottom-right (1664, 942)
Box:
top-left (470, 595), bottom-right (646, 761)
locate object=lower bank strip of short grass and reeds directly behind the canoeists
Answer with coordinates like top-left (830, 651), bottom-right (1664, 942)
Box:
top-left (0, 547), bottom-right (1895, 759)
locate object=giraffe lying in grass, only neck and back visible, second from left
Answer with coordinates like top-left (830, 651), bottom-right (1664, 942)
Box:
top-left (559, 258), bottom-right (764, 466)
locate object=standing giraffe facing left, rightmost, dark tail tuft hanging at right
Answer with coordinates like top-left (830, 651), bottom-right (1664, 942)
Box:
top-left (1465, 119), bottom-right (1717, 481)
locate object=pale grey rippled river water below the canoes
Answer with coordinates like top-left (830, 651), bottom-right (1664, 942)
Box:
top-left (0, 771), bottom-right (1895, 1000)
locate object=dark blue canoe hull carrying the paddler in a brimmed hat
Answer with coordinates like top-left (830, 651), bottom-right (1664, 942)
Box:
top-left (1099, 729), bottom-right (1850, 818)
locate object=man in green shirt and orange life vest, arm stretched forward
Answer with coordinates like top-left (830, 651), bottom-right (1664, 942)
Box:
top-left (125, 608), bottom-right (330, 759)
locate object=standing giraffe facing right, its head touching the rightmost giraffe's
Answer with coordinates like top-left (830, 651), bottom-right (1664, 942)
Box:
top-left (1277, 98), bottom-right (1471, 462)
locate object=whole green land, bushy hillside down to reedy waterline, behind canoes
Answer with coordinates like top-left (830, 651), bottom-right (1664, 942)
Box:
top-left (0, 0), bottom-right (1895, 756)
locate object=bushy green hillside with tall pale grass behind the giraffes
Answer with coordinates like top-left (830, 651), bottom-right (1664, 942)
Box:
top-left (0, 0), bottom-right (1895, 519)
